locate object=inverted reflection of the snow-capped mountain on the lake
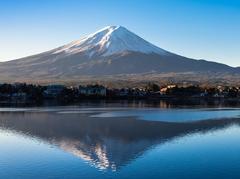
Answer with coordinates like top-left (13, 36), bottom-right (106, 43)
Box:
top-left (0, 111), bottom-right (240, 170)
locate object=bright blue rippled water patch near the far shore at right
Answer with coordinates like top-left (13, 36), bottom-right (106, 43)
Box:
top-left (92, 108), bottom-right (240, 122)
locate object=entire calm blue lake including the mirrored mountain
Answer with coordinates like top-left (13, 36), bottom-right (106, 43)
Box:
top-left (0, 101), bottom-right (240, 179)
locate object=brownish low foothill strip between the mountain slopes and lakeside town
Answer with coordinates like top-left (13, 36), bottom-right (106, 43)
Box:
top-left (0, 72), bottom-right (240, 88)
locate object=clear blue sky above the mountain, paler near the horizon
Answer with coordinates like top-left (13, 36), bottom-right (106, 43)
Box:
top-left (0, 0), bottom-right (240, 66)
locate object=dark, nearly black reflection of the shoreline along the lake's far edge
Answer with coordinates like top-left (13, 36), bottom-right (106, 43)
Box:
top-left (0, 98), bottom-right (240, 108)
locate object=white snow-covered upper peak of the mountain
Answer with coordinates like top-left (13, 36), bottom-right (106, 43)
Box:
top-left (54, 26), bottom-right (168, 57)
